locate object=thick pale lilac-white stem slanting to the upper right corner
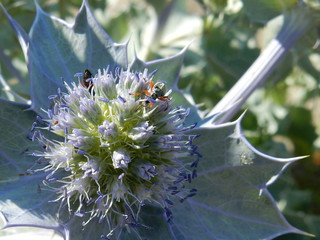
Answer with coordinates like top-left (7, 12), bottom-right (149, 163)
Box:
top-left (207, 6), bottom-right (316, 124)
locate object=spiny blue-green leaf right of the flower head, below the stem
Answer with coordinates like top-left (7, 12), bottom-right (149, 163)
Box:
top-left (168, 119), bottom-right (302, 240)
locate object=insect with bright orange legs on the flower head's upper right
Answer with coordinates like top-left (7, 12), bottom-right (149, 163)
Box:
top-left (130, 81), bottom-right (170, 108)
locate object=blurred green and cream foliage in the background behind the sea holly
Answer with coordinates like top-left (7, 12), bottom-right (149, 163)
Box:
top-left (0, 0), bottom-right (320, 240)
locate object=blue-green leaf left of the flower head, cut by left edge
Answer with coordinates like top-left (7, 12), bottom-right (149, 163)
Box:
top-left (0, 99), bottom-right (61, 231)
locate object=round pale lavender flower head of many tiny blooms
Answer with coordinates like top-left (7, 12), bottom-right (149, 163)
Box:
top-left (33, 68), bottom-right (199, 238)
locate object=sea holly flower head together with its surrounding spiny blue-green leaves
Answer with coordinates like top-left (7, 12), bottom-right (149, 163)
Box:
top-left (0, 0), bottom-right (318, 240)
